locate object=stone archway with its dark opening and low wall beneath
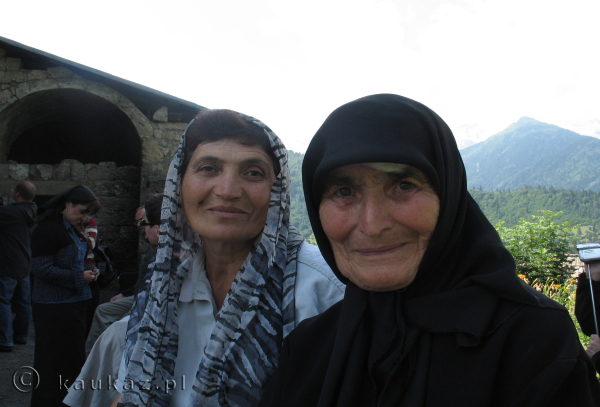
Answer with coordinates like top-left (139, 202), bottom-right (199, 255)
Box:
top-left (0, 75), bottom-right (154, 276)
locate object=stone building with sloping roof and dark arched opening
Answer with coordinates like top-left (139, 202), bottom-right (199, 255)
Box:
top-left (0, 37), bottom-right (204, 269)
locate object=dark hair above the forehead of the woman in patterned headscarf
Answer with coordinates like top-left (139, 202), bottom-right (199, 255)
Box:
top-left (181, 109), bottom-right (279, 177)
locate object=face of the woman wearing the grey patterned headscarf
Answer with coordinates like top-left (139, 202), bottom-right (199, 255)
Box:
top-left (182, 140), bottom-right (275, 247)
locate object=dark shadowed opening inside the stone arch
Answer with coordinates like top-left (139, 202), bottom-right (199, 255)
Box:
top-left (0, 89), bottom-right (141, 168)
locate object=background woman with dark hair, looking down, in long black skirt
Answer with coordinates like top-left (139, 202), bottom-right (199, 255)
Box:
top-left (31, 185), bottom-right (100, 407)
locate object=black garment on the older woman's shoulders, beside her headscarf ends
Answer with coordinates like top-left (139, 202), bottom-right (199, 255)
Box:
top-left (260, 300), bottom-right (600, 407)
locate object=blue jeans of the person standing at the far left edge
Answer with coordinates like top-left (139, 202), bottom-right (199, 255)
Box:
top-left (0, 276), bottom-right (31, 346)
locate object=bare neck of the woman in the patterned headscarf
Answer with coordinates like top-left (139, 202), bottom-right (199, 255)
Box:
top-left (204, 241), bottom-right (254, 309)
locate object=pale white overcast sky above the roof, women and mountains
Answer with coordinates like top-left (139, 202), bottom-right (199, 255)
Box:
top-left (0, 0), bottom-right (600, 152)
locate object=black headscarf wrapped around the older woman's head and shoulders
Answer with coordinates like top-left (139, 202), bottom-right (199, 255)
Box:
top-left (302, 94), bottom-right (559, 406)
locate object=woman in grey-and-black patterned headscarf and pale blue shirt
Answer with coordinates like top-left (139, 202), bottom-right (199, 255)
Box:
top-left (118, 110), bottom-right (343, 406)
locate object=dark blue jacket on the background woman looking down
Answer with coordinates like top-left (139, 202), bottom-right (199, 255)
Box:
top-left (31, 219), bottom-right (91, 303)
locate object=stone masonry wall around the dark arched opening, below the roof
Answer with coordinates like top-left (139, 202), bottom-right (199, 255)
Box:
top-left (0, 43), bottom-right (197, 274)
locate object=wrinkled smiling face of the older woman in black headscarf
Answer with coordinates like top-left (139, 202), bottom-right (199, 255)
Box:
top-left (319, 164), bottom-right (440, 291)
